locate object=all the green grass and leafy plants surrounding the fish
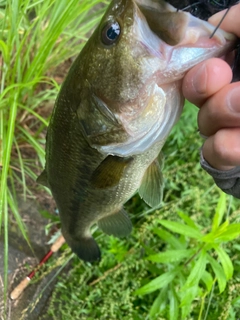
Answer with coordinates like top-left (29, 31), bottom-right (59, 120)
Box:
top-left (0, 0), bottom-right (240, 320)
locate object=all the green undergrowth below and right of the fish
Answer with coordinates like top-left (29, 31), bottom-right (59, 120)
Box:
top-left (42, 118), bottom-right (240, 320)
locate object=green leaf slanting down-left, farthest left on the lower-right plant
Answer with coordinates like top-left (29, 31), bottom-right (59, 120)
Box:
top-left (134, 268), bottom-right (178, 295)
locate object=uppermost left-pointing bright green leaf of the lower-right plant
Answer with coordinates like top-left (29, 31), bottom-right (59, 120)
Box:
top-left (159, 220), bottom-right (203, 240)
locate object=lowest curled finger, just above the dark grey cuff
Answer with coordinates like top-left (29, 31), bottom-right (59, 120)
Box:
top-left (202, 128), bottom-right (240, 170)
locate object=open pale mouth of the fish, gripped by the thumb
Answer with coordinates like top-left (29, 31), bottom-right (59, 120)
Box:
top-left (135, 0), bottom-right (235, 47)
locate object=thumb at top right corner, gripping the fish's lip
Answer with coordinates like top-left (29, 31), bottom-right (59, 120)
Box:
top-left (208, 4), bottom-right (240, 37)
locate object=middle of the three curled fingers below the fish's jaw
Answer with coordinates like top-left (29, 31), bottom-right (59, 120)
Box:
top-left (198, 82), bottom-right (240, 136)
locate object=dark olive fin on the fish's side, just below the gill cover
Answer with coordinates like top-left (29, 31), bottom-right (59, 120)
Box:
top-left (90, 156), bottom-right (133, 189)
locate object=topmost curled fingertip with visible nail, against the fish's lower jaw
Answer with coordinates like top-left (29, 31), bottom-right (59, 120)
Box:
top-left (182, 58), bottom-right (232, 107)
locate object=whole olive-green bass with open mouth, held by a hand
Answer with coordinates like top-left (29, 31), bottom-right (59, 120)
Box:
top-left (37, 0), bottom-right (235, 262)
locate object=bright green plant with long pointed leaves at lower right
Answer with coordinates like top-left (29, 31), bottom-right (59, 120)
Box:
top-left (135, 192), bottom-right (240, 320)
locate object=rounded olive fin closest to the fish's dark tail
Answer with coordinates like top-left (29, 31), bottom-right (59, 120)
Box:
top-left (98, 208), bottom-right (132, 238)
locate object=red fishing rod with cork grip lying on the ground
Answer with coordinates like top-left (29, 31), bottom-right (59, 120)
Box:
top-left (10, 234), bottom-right (65, 300)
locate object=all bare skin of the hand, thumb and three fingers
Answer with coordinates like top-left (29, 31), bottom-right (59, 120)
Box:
top-left (183, 4), bottom-right (240, 170)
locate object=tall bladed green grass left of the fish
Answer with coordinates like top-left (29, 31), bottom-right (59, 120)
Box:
top-left (0, 0), bottom-right (106, 312)
